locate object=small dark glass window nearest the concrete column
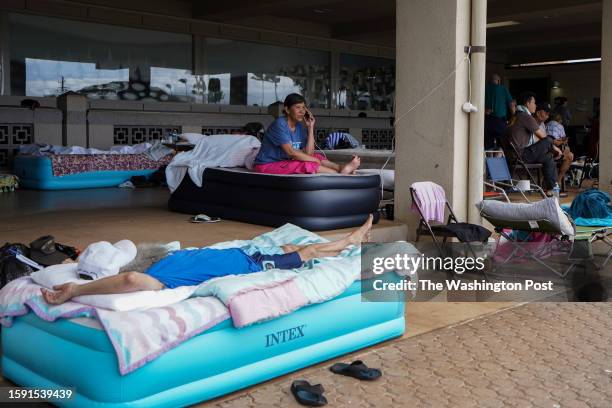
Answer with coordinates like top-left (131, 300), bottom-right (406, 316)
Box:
top-left (333, 54), bottom-right (395, 111)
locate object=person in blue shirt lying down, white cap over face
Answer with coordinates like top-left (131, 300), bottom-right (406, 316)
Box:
top-left (41, 215), bottom-right (373, 305)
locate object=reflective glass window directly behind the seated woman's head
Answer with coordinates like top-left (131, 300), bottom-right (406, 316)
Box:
top-left (204, 38), bottom-right (330, 108)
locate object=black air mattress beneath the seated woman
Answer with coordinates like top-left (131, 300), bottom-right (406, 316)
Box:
top-left (168, 168), bottom-right (381, 231)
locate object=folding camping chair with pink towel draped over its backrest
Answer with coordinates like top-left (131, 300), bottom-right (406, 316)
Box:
top-left (410, 182), bottom-right (488, 266)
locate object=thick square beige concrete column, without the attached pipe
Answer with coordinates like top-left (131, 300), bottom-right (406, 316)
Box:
top-left (395, 0), bottom-right (470, 239)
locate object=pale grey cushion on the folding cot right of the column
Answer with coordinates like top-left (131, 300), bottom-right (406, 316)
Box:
top-left (476, 197), bottom-right (576, 236)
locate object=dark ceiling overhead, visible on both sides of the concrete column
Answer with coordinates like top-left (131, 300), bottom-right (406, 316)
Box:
top-left (192, 0), bottom-right (602, 63)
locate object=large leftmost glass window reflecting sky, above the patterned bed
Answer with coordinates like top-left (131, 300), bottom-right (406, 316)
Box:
top-left (9, 14), bottom-right (194, 102)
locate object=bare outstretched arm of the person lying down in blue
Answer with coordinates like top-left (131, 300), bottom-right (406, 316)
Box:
top-left (41, 272), bottom-right (164, 305)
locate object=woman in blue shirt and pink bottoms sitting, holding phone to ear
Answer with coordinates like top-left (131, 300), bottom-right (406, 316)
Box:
top-left (253, 93), bottom-right (361, 174)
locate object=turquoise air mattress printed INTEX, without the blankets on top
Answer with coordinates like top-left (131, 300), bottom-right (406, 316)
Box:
top-left (2, 274), bottom-right (404, 408)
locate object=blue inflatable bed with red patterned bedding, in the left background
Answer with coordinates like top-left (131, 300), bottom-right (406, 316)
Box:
top-left (14, 154), bottom-right (170, 190)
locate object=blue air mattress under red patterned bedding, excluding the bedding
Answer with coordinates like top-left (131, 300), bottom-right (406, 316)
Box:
top-left (13, 156), bottom-right (155, 190)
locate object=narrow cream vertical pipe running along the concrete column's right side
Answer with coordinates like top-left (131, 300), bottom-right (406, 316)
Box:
top-left (467, 0), bottom-right (487, 224)
